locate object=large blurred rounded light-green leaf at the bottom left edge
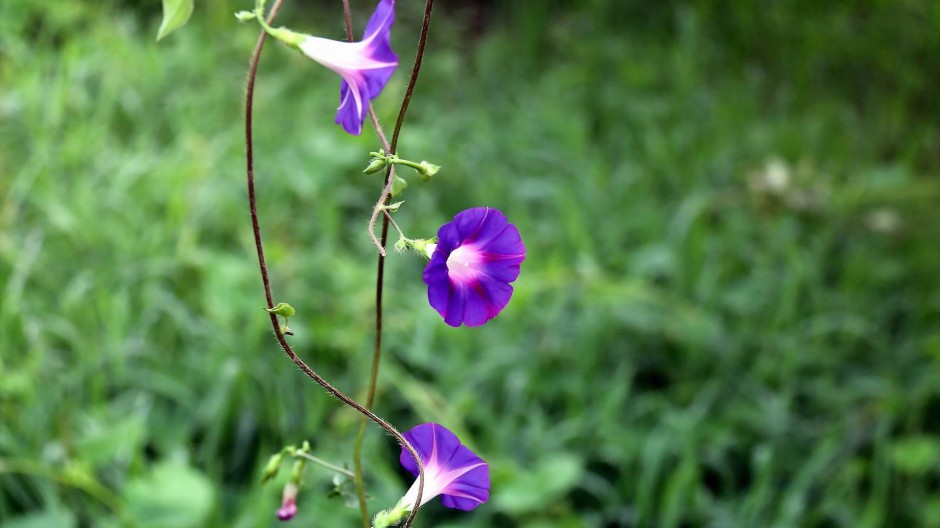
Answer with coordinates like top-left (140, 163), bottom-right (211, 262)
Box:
top-left (124, 462), bottom-right (215, 528)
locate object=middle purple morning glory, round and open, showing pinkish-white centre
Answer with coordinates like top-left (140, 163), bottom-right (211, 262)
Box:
top-left (424, 207), bottom-right (525, 326)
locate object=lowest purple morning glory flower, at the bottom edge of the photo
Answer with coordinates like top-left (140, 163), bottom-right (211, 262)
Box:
top-left (400, 423), bottom-right (490, 511)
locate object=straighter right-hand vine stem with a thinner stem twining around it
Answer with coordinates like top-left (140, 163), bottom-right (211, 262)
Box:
top-left (343, 0), bottom-right (434, 528)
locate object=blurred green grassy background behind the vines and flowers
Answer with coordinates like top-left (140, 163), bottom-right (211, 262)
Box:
top-left (0, 0), bottom-right (940, 528)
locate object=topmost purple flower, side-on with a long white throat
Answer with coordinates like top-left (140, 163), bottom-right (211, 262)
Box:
top-left (297, 0), bottom-right (398, 136)
